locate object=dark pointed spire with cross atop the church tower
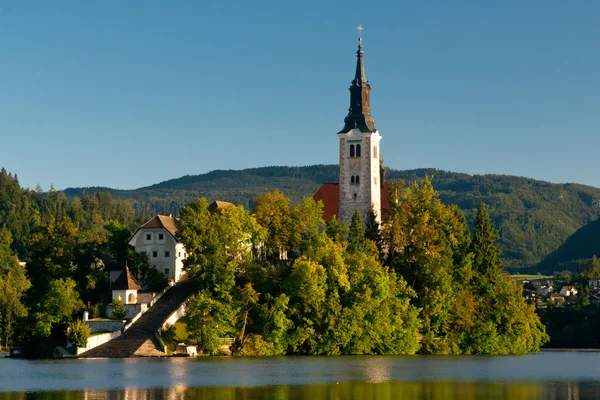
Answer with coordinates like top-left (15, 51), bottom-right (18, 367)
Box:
top-left (339, 25), bottom-right (375, 133)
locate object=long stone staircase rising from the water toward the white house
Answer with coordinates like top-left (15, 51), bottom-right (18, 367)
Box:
top-left (79, 277), bottom-right (195, 358)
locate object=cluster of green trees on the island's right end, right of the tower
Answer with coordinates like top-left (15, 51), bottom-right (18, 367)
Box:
top-left (382, 178), bottom-right (547, 354)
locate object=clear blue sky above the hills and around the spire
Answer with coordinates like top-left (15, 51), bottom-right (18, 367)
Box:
top-left (0, 0), bottom-right (600, 190)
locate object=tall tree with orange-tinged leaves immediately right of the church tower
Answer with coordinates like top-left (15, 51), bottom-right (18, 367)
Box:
top-left (382, 178), bottom-right (467, 353)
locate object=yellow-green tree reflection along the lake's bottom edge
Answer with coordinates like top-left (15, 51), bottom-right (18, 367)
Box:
top-left (0, 382), bottom-right (600, 400)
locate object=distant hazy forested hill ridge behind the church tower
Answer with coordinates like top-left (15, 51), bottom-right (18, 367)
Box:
top-left (65, 165), bottom-right (600, 268)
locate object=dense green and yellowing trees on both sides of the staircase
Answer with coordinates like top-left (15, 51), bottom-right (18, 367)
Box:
top-left (0, 170), bottom-right (548, 356)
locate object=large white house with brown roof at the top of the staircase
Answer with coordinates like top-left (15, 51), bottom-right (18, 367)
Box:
top-left (129, 215), bottom-right (187, 282)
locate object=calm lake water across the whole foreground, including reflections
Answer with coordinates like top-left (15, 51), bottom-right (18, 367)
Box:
top-left (0, 352), bottom-right (600, 400)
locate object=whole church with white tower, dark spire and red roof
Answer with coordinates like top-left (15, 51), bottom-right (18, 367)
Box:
top-left (313, 32), bottom-right (389, 223)
